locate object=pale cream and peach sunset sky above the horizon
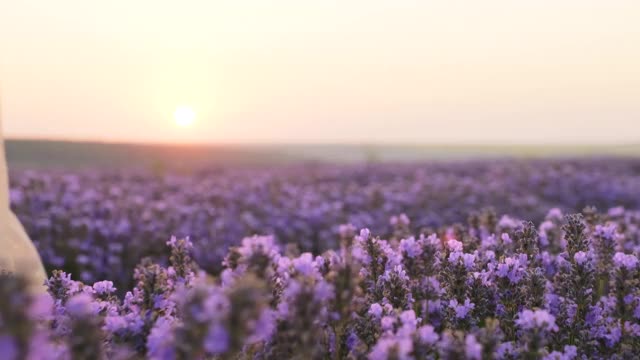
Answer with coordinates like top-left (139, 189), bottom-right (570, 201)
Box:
top-left (0, 0), bottom-right (640, 144)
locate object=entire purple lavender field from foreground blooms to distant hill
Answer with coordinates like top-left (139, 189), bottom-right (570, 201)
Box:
top-left (0, 158), bottom-right (640, 359)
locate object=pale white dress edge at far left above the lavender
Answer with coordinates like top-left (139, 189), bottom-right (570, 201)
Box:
top-left (0, 120), bottom-right (45, 292)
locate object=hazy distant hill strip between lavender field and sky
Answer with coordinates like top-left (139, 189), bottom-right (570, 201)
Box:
top-left (6, 140), bottom-right (640, 168)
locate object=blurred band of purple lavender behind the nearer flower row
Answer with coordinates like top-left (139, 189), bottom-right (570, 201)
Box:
top-left (11, 159), bottom-right (640, 289)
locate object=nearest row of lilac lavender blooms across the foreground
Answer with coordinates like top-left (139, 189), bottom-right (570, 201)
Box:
top-left (0, 202), bottom-right (640, 360)
